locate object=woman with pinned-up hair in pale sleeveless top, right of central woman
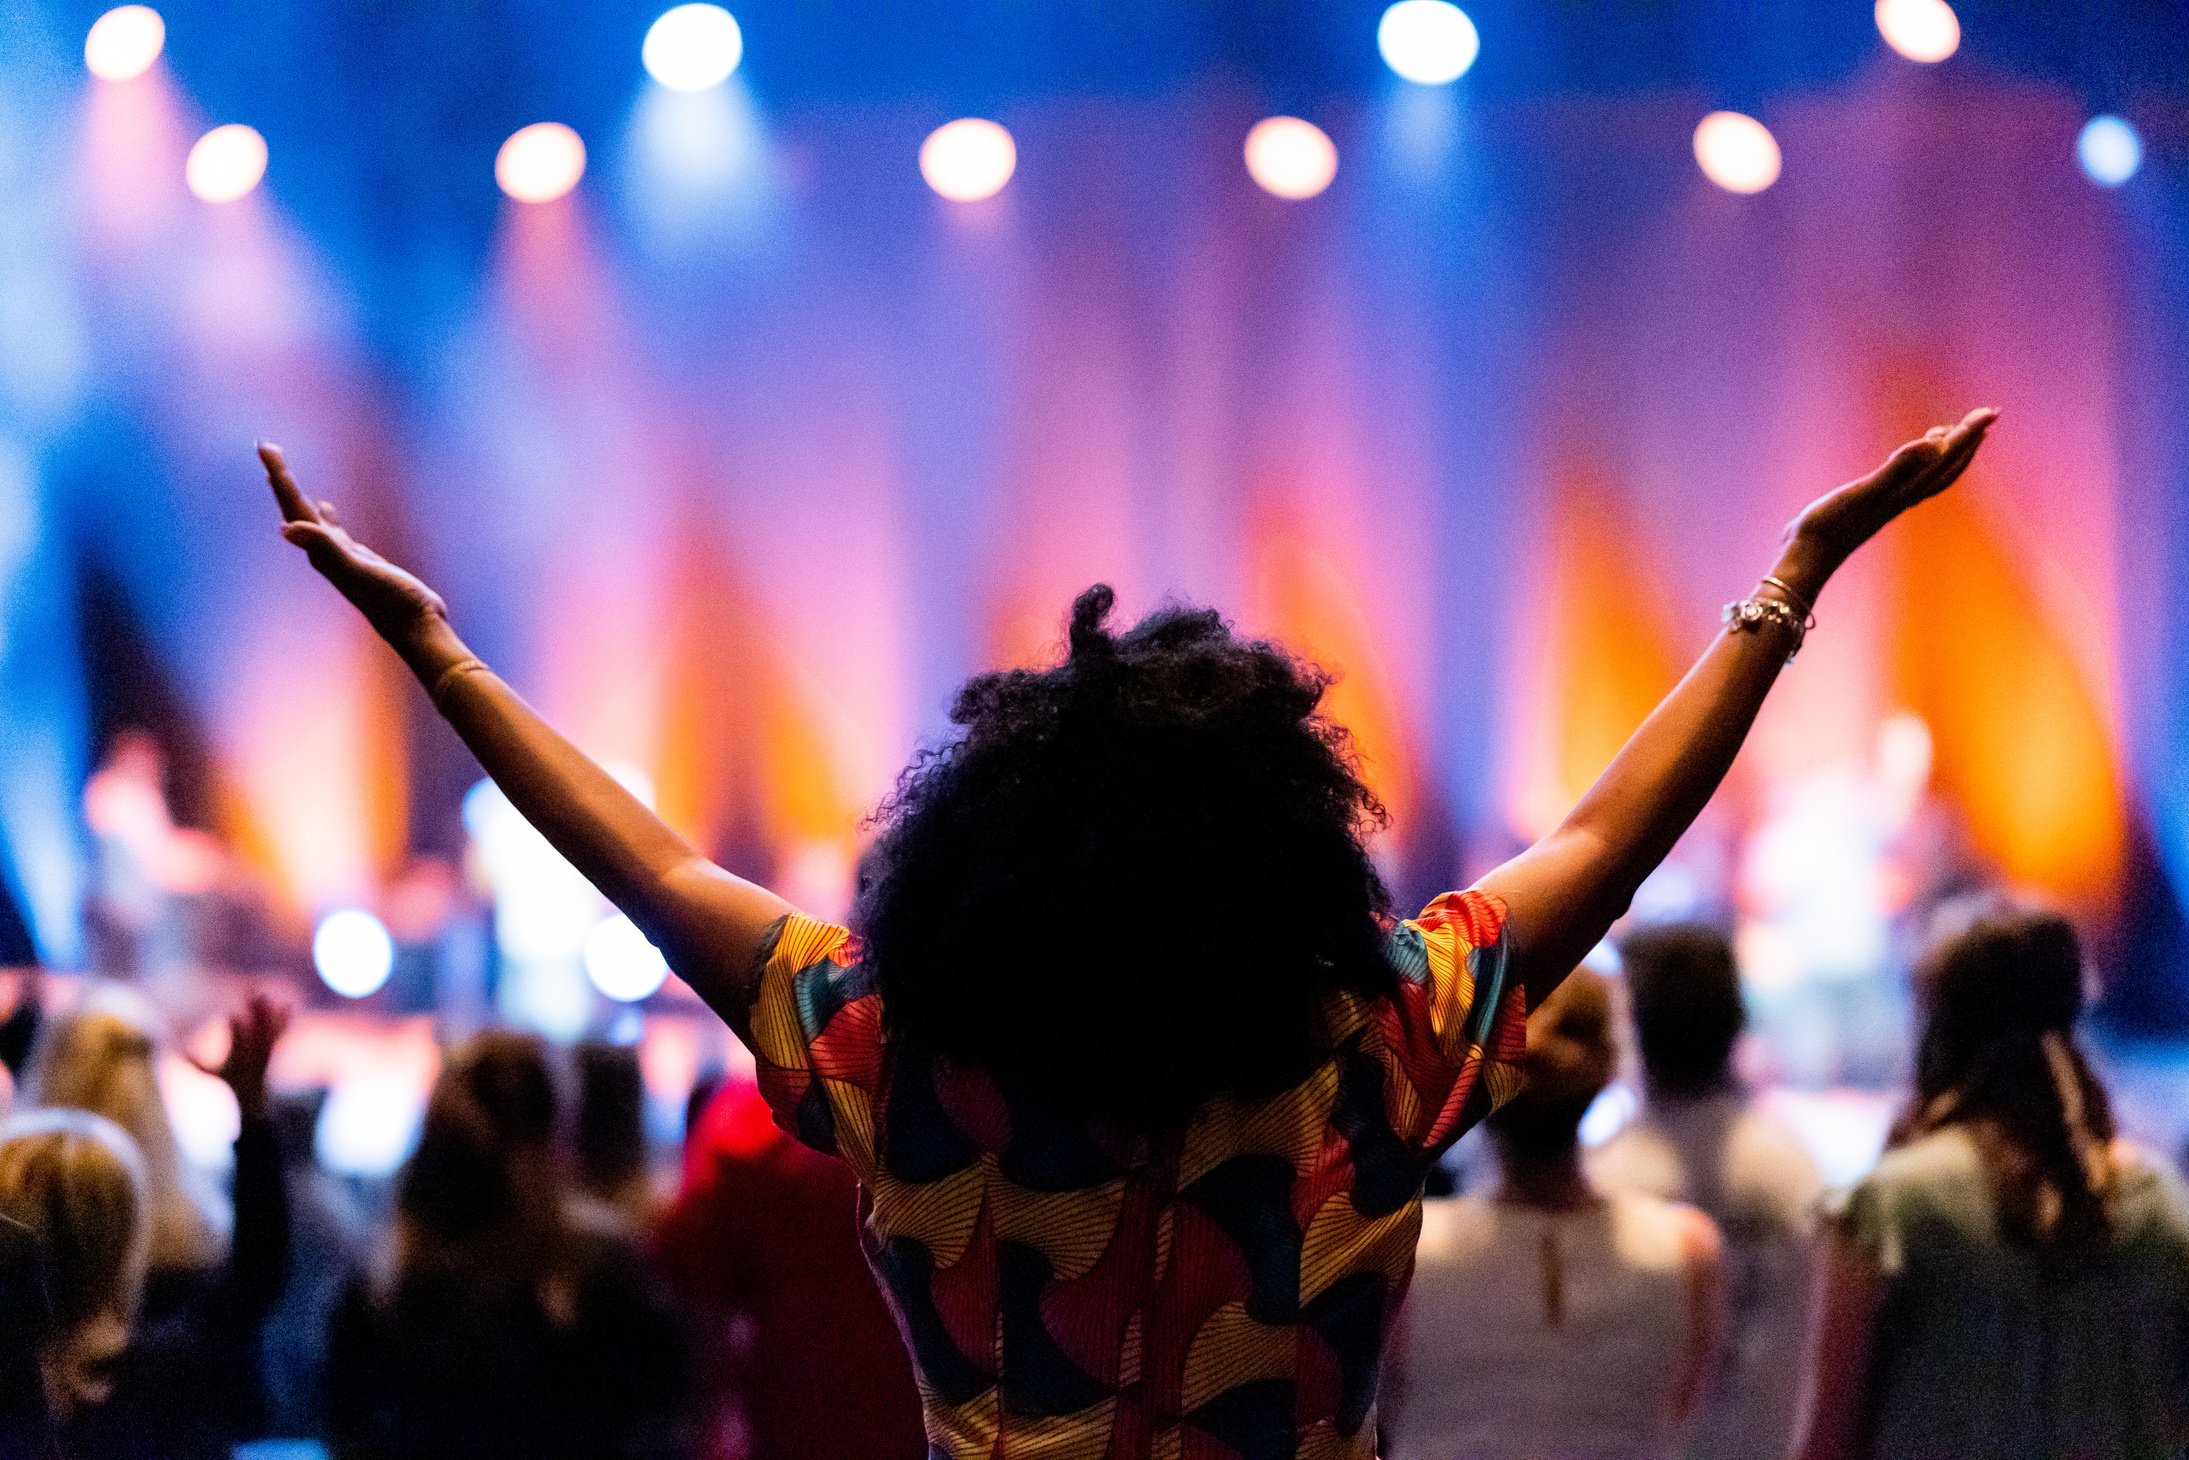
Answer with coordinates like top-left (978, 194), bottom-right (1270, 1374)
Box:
top-left (1390, 970), bottom-right (1725, 1460)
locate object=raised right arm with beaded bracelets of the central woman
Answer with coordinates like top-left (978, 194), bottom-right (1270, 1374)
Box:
top-left (1482, 409), bottom-right (1999, 1007)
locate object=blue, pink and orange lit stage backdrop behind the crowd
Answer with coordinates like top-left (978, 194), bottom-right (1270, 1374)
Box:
top-left (0, 2), bottom-right (2189, 1024)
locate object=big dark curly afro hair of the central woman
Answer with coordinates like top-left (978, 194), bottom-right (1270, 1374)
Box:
top-left (856, 584), bottom-right (1397, 1129)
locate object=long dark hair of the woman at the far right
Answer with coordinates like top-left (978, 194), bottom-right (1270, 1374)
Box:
top-left (1898, 904), bottom-right (2112, 1248)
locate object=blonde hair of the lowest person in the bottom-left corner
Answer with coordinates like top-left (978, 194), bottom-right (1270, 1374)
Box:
top-left (0, 1110), bottom-right (149, 1333)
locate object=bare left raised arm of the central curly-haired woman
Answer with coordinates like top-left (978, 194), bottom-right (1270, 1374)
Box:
top-left (258, 444), bottom-right (790, 1040)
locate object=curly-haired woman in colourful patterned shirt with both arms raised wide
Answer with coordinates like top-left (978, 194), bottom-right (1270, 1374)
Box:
top-left (260, 402), bottom-right (1994, 1458)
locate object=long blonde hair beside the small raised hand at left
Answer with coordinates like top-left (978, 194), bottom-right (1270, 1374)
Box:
top-left (28, 1000), bottom-right (223, 1272)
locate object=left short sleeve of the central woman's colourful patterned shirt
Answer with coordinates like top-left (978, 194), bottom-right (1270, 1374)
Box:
top-left (753, 913), bottom-right (882, 1180)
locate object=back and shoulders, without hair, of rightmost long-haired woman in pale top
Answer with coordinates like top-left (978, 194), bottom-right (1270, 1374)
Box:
top-left (1843, 1127), bottom-right (2189, 1460)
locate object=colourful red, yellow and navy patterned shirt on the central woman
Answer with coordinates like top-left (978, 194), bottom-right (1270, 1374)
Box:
top-left (753, 891), bottom-right (1526, 1460)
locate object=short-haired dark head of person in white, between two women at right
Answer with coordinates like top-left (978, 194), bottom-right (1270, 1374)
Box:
top-left (1620, 924), bottom-right (1747, 1094)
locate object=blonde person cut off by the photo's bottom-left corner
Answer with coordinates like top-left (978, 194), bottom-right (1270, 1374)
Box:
top-left (0, 1110), bottom-right (151, 1460)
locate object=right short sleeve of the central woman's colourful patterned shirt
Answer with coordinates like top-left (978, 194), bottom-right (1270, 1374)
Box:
top-left (1373, 891), bottom-right (1528, 1149)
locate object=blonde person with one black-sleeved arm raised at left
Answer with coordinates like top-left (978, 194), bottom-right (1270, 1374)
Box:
top-left (31, 994), bottom-right (289, 1460)
